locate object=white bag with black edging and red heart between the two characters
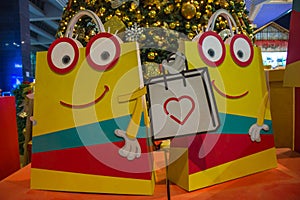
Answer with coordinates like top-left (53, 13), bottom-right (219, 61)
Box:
top-left (147, 68), bottom-right (219, 140)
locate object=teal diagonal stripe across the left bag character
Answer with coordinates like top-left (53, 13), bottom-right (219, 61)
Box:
top-left (32, 115), bottom-right (147, 153)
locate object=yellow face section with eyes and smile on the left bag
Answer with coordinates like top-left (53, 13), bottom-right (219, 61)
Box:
top-left (35, 32), bottom-right (140, 133)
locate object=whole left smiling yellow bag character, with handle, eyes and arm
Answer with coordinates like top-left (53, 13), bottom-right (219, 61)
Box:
top-left (31, 10), bottom-right (154, 195)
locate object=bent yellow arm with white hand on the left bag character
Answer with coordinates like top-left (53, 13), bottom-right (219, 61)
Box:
top-left (115, 87), bottom-right (149, 160)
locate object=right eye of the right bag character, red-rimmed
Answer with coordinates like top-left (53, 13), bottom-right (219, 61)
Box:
top-left (230, 34), bottom-right (253, 67)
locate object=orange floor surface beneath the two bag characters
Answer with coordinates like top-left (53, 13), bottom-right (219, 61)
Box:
top-left (0, 148), bottom-right (300, 200)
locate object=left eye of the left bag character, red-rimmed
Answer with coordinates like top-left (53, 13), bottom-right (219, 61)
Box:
top-left (47, 38), bottom-right (79, 74)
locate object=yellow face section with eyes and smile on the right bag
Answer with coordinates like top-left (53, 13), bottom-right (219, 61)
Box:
top-left (186, 31), bottom-right (270, 118)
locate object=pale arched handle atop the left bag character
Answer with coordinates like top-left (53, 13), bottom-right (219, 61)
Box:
top-left (65, 10), bottom-right (105, 38)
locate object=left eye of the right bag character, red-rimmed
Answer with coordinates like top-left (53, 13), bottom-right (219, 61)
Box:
top-left (198, 31), bottom-right (226, 66)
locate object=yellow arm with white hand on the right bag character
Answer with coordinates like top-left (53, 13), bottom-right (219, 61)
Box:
top-left (249, 92), bottom-right (269, 142)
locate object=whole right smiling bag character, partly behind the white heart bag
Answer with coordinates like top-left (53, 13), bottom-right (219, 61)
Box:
top-left (169, 9), bottom-right (277, 191)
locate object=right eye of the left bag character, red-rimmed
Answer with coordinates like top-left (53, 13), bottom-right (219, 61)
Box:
top-left (86, 32), bottom-right (121, 71)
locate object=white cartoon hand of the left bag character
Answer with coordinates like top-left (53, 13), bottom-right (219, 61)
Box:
top-left (115, 129), bottom-right (141, 160)
